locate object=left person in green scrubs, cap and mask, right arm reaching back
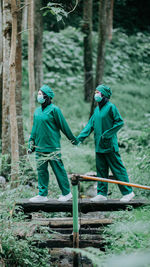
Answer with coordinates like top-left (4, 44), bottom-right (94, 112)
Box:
top-left (28, 85), bottom-right (77, 202)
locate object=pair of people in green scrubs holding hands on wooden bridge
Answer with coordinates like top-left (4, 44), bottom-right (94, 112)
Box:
top-left (28, 84), bottom-right (134, 202)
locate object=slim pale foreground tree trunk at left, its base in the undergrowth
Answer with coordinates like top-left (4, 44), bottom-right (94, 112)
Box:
top-left (9, 0), bottom-right (19, 186)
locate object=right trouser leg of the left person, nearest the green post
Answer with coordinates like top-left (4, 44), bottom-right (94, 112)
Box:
top-left (50, 155), bottom-right (70, 196)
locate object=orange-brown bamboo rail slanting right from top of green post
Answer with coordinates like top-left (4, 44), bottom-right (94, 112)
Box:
top-left (76, 175), bottom-right (150, 190)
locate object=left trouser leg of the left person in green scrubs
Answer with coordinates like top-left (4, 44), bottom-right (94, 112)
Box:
top-left (36, 153), bottom-right (49, 196)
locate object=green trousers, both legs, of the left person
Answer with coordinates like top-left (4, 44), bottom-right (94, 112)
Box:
top-left (36, 153), bottom-right (70, 196)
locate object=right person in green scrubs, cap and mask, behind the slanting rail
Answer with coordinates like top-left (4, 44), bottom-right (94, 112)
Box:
top-left (77, 84), bottom-right (134, 202)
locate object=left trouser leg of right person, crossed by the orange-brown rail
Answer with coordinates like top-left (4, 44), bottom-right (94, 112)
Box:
top-left (96, 153), bottom-right (109, 196)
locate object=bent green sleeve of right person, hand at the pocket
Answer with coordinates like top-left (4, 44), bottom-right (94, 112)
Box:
top-left (102, 105), bottom-right (124, 139)
